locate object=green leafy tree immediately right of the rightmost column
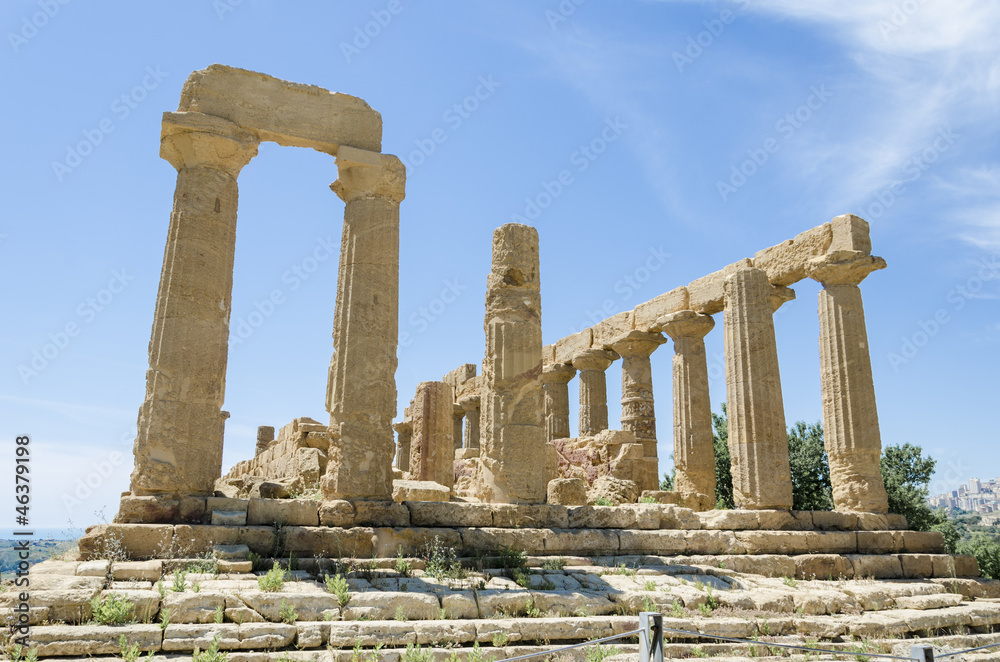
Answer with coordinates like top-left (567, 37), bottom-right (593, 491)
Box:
top-left (880, 444), bottom-right (942, 531)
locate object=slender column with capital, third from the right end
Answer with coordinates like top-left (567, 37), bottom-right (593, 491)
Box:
top-left (657, 310), bottom-right (715, 503)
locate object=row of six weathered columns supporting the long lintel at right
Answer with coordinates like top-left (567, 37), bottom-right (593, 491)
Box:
top-left (542, 262), bottom-right (888, 513)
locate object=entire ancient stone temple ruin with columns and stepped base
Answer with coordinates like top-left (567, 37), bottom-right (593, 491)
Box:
top-left (15, 65), bottom-right (1000, 662)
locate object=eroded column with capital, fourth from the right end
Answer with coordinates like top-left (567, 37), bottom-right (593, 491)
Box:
top-left (611, 331), bottom-right (666, 490)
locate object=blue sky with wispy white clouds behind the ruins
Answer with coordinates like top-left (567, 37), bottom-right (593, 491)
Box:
top-left (0, 0), bottom-right (1000, 527)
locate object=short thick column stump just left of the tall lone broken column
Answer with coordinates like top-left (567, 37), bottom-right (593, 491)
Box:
top-left (410, 382), bottom-right (455, 488)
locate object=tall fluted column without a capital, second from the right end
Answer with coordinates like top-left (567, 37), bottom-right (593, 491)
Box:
top-left (723, 268), bottom-right (792, 509)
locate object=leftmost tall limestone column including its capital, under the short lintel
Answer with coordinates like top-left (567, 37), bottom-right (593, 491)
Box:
top-left (131, 113), bottom-right (258, 496)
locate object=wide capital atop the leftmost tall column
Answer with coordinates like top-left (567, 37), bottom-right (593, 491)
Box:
top-left (160, 113), bottom-right (260, 179)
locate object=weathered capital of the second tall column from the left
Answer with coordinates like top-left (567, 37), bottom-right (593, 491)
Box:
top-left (330, 145), bottom-right (406, 204)
